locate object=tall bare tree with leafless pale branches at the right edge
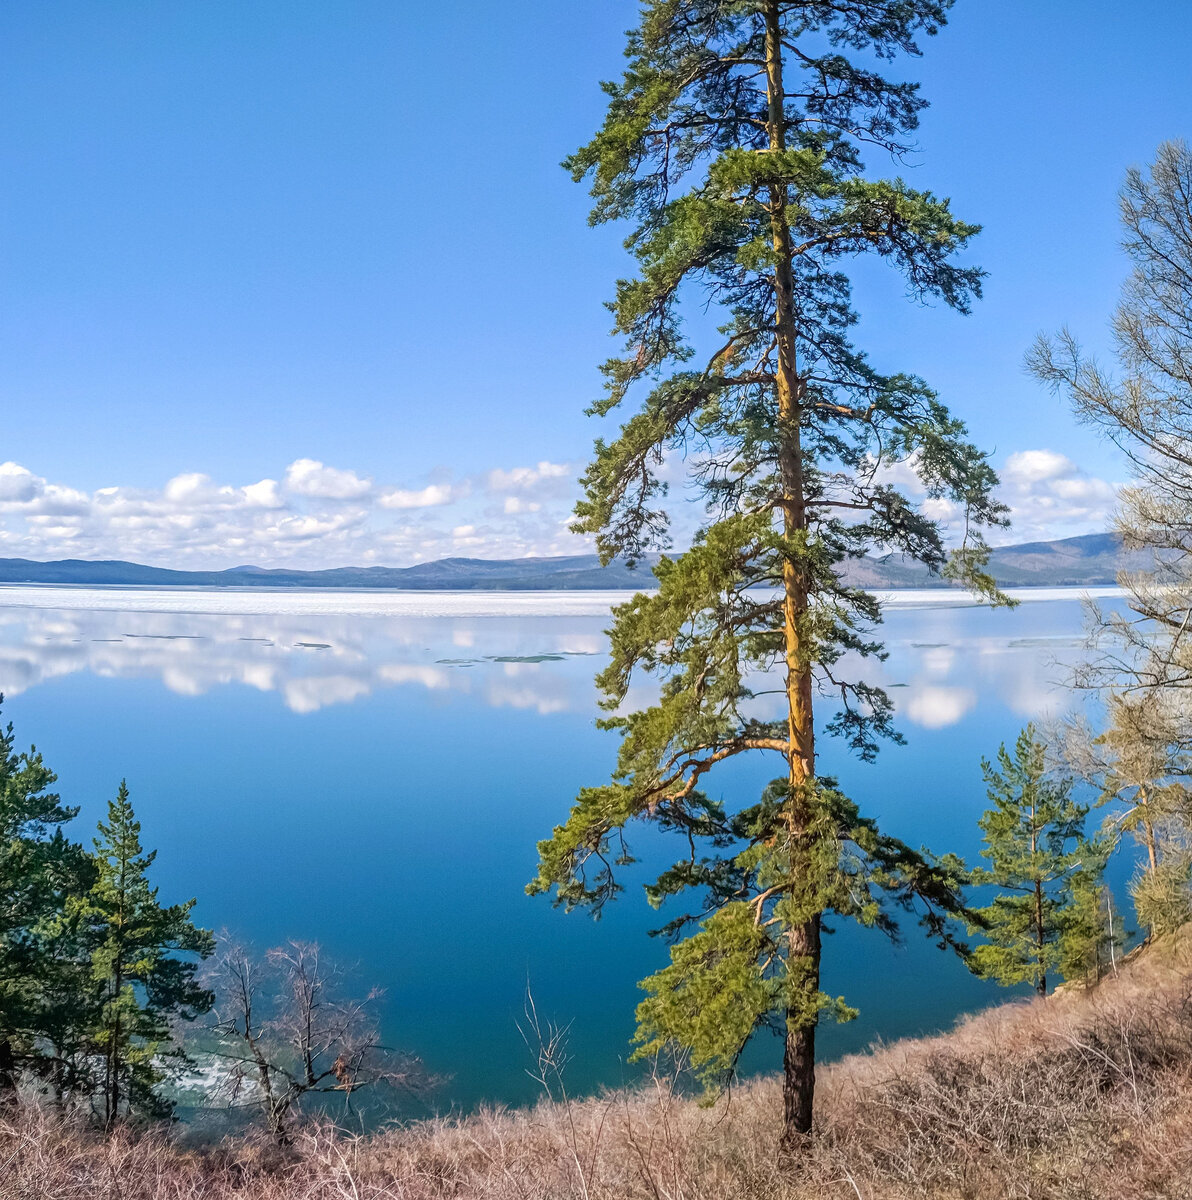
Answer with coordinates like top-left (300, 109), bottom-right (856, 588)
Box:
top-left (1028, 142), bottom-right (1192, 928)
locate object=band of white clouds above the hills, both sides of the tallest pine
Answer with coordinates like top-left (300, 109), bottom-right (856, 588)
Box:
top-left (0, 450), bottom-right (1115, 570)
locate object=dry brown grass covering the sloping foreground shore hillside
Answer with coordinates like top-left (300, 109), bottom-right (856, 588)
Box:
top-left (0, 931), bottom-right (1192, 1200)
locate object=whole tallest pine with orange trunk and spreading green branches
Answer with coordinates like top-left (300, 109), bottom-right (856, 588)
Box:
top-left (529, 0), bottom-right (1005, 1144)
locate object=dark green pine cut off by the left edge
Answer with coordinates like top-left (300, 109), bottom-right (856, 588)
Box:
top-left (0, 697), bottom-right (88, 1098)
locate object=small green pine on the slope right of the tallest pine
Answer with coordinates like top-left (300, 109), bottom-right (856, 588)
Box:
top-left (971, 725), bottom-right (1103, 996)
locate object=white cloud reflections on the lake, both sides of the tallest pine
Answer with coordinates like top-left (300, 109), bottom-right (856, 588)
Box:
top-left (0, 601), bottom-right (1082, 730)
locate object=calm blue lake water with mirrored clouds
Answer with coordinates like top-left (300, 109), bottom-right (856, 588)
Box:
top-left (0, 588), bottom-right (1126, 1108)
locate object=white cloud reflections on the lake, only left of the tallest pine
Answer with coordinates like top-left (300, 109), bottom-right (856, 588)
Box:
top-left (0, 607), bottom-right (603, 713)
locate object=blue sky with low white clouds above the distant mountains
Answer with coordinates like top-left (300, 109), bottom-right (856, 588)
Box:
top-left (0, 0), bottom-right (1192, 566)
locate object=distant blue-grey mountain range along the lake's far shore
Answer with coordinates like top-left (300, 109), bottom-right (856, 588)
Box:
top-left (0, 533), bottom-right (1134, 592)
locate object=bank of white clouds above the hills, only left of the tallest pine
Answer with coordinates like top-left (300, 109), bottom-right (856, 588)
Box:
top-left (0, 458), bottom-right (585, 570)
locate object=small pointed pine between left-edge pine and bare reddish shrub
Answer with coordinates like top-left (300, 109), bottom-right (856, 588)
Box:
top-left (86, 781), bottom-right (215, 1127)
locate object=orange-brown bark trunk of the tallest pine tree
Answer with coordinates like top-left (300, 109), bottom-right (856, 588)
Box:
top-left (765, 0), bottom-right (820, 1147)
